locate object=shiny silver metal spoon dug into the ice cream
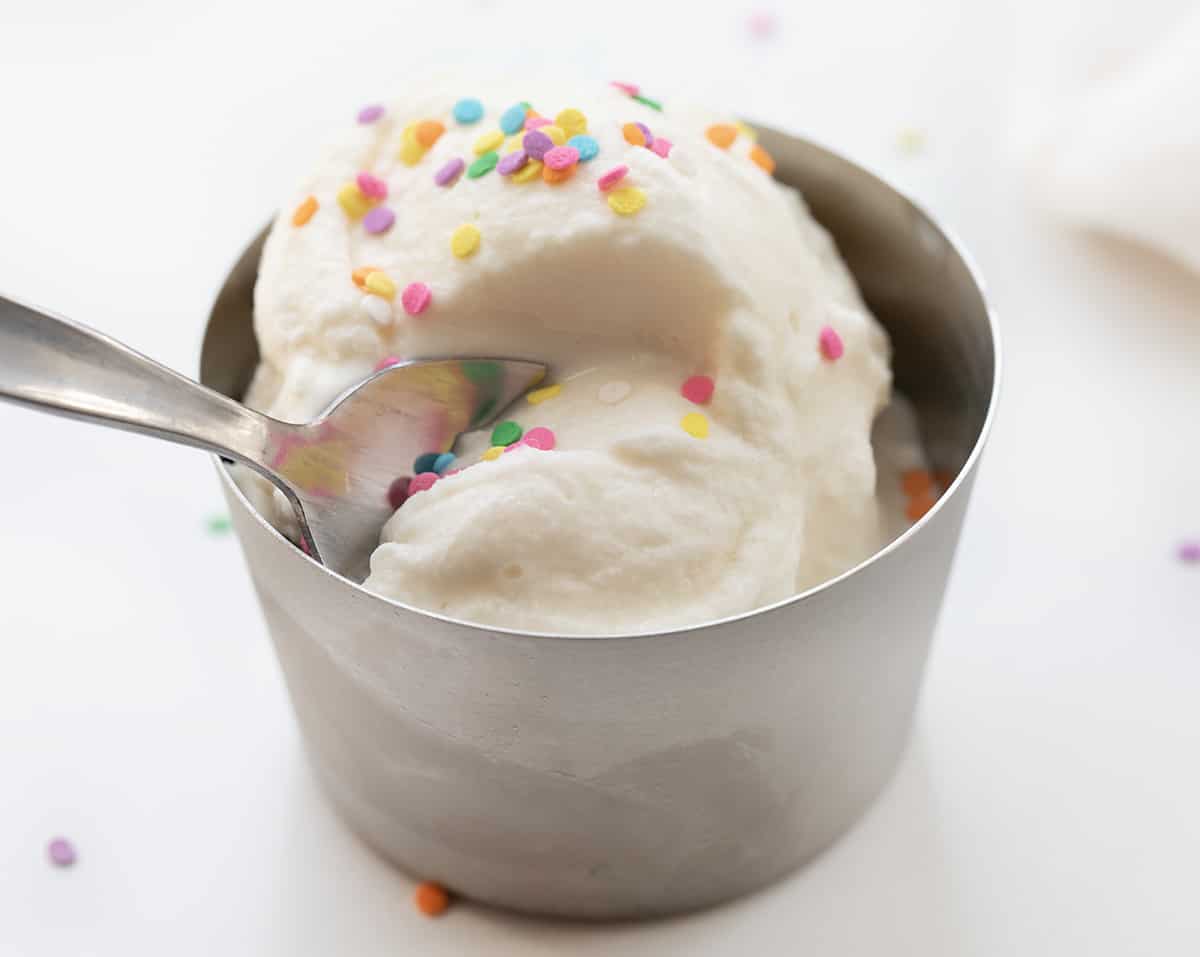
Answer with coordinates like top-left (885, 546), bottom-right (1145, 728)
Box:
top-left (0, 296), bottom-right (546, 580)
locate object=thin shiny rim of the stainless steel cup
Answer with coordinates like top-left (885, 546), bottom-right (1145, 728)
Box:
top-left (205, 124), bottom-right (1003, 640)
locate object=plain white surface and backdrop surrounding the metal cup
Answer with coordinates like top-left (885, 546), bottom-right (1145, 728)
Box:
top-left (0, 0), bottom-right (1200, 957)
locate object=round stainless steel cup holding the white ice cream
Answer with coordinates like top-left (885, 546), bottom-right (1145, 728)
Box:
top-left (202, 130), bottom-right (998, 917)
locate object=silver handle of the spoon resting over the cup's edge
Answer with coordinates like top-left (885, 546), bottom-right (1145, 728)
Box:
top-left (0, 296), bottom-right (278, 471)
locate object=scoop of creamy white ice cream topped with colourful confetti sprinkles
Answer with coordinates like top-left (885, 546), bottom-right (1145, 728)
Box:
top-left (250, 78), bottom-right (890, 633)
